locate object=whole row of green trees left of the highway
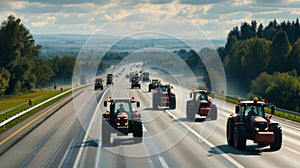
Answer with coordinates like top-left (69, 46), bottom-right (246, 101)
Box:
top-left (0, 15), bottom-right (75, 95)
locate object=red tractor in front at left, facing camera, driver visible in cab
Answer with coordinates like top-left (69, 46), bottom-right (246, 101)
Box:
top-left (102, 97), bottom-right (143, 144)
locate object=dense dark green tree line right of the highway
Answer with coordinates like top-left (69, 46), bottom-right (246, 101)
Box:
top-left (217, 19), bottom-right (300, 111)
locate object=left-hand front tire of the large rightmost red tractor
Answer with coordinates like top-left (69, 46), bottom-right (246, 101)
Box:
top-left (234, 125), bottom-right (247, 150)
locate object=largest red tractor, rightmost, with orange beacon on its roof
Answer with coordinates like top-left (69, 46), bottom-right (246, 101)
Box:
top-left (226, 97), bottom-right (282, 151)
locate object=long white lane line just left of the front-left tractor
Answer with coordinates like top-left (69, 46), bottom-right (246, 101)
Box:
top-left (73, 89), bottom-right (108, 167)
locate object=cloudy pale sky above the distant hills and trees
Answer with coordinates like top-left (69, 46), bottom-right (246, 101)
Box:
top-left (0, 0), bottom-right (300, 39)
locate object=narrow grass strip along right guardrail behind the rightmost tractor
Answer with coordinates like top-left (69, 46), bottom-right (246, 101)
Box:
top-left (220, 95), bottom-right (300, 123)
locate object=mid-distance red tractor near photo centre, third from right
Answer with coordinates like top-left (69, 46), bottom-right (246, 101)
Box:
top-left (152, 85), bottom-right (176, 110)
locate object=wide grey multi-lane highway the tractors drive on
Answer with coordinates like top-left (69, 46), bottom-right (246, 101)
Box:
top-left (0, 64), bottom-right (300, 168)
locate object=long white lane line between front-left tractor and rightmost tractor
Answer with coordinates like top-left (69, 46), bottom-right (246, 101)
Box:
top-left (165, 110), bottom-right (244, 168)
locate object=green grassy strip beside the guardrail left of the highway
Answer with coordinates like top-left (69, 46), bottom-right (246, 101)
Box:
top-left (0, 89), bottom-right (72, 134)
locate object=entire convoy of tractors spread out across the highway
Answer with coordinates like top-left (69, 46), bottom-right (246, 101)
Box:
top-left (95, 65), bottom-right (282, 150)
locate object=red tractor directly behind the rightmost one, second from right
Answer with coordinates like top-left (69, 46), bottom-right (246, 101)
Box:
top-left (186, 89), bottom-right (218, 121)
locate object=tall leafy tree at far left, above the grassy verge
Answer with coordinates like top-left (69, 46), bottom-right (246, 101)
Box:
top-left (0, 15), bottom-right (41, 94)
